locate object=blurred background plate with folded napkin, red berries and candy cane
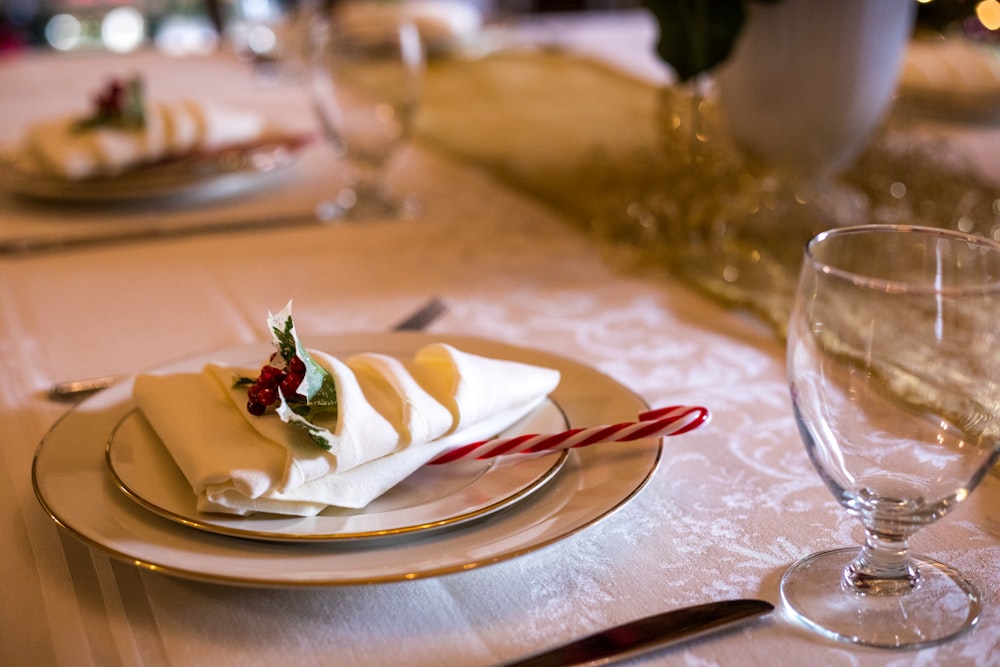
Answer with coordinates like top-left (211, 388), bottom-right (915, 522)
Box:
top-left (0, 67), bottom-right (312, 204)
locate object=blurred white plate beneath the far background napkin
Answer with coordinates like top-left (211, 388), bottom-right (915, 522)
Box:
top-left (0, 137), bottom-right (305, 204)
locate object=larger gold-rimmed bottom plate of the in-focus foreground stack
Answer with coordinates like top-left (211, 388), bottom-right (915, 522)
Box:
top-left (32, 333), bottom-right (661, 586)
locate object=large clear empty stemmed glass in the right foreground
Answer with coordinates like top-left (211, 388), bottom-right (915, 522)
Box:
top-left (781, 225), bottom-right (1000, 648)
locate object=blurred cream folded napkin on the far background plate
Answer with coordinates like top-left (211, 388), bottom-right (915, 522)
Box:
top-left (20, 100), bottom-right (267, 179)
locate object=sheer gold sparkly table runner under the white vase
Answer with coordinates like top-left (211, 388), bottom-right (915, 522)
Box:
top-left (418, 51), bottom-right (1000, 470)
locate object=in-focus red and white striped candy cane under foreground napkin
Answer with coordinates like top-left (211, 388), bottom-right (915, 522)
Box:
top-left (430, 405), bottom-right (712, 464)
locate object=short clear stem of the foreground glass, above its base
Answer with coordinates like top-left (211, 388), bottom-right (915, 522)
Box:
top-left (841, 527), bottom-right (920, 595)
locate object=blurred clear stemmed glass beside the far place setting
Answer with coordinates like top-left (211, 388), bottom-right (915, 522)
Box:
top-left (311, 0), bottom-right (425, 220)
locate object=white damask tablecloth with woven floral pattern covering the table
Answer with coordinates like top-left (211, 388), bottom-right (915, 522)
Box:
top-left (0, 13), bottom-right (1000, 666)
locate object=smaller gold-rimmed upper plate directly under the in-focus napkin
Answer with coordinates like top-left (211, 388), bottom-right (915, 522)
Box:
top-left (107, 400), bottom-right (567, 542)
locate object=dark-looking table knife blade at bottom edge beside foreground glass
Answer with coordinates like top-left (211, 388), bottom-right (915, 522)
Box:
top-left (501, 600), bottom-right (774, 667)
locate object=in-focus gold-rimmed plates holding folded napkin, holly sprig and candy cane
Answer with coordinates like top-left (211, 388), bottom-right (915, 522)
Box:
top-left (33, 304), bottom-right (710, 586)
